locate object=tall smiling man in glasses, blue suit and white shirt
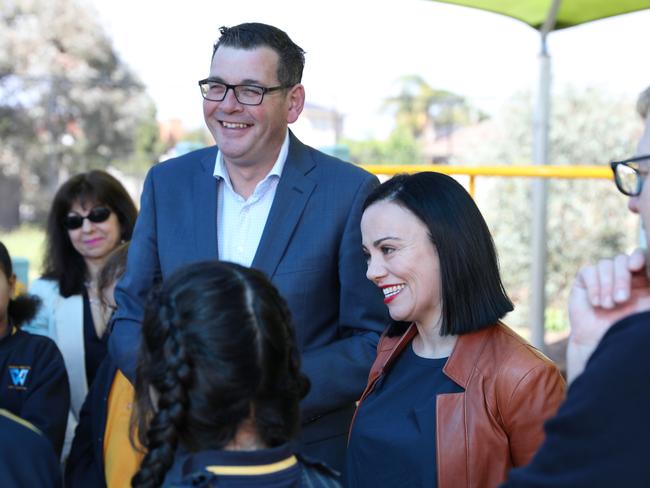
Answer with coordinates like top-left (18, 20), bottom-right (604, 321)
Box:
top-left (109, 23), bottom-right (388, 470)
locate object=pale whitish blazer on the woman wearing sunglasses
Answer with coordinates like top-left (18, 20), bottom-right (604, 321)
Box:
top-left (23, 279), bottom-right (88, 459)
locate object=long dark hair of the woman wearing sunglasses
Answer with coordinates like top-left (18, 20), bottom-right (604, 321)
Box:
top-left (43, 170), bottom-right (138, 297)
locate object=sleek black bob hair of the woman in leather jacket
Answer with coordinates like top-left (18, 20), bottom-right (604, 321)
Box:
top-left (363, 172), bottom-right (513, 335)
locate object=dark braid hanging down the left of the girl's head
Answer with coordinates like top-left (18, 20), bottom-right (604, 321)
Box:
top-left (132, 298), bottom-right (192, 488)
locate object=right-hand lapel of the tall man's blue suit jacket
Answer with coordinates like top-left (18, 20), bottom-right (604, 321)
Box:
top-left (252, 132), bottom-right (317, 277)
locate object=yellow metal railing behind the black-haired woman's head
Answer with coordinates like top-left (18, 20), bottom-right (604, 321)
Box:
top-left (361, 164), bottom-right (613, 196)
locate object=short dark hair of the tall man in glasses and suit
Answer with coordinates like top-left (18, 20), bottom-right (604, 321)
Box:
top-left (212, 22), bottom-right (305, 86)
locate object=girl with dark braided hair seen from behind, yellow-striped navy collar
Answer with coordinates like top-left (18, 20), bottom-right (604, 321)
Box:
top-left (132, 261), bottom-right (339, 487)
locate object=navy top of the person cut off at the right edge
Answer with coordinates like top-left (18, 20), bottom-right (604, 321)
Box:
top-left (503, 312), bottom-right (650, 488)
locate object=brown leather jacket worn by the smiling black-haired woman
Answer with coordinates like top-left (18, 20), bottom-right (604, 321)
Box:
top-left (350, 322), bottom-right (566, 488)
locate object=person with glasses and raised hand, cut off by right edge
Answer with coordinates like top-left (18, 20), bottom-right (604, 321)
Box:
top-left (503, 87), bottom-right (650, 488)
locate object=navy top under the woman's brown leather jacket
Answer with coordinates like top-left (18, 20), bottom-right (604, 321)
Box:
top-left (347, 344), bottom-right (463, 488)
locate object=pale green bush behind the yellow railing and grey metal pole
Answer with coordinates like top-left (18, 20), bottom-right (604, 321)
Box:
top-left (457, 88), bottom-right (640, 328)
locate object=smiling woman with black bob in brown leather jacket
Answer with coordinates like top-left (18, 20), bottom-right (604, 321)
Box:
top-left (347, 172), bottom-right (565, 488)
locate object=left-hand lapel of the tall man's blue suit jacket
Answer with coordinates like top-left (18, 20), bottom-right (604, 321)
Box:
top-left (192, 151), bottom-right (219, 261)
